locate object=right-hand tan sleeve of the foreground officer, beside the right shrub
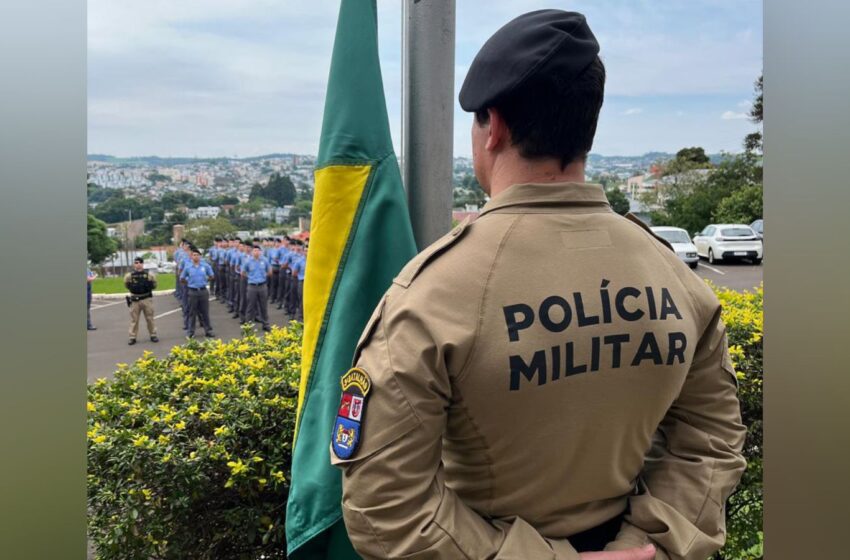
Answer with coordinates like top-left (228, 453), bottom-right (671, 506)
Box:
top-left (605, 310), bottom-right (747, 560)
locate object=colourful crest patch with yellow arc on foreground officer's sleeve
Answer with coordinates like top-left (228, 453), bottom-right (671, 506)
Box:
top-left (331, 368), bottom-right (372, 459)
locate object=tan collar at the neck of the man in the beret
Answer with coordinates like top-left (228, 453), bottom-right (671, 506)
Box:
top-left (481, 183), bottom-right (608, 216)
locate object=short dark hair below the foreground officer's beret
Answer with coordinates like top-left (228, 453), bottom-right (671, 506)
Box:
top-left (475, 57), bottom-right (605, 169)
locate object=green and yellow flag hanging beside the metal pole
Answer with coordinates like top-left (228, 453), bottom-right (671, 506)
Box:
top-left (286, 0), bottom-right (416, 560)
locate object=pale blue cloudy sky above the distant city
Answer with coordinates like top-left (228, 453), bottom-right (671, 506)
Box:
top-left (88, 0), bottom-right (762, 157)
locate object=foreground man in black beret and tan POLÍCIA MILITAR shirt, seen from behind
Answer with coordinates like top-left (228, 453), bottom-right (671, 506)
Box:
top-left (331, 10), bottom-right (746, 560)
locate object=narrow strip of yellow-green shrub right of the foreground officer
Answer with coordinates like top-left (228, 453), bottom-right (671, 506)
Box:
top-left (715, 287), bottom-right (764, 560)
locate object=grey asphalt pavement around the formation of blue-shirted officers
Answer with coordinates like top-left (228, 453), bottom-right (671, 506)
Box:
top-left (88, 294), bottom-right (298, 382)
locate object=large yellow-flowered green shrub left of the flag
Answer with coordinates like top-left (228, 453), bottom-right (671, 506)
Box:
top-left (87, 323), bottom-right (301, 560)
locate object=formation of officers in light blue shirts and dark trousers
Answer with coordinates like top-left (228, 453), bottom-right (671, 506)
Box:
top-left (174, 237), bottom-right (307, 338)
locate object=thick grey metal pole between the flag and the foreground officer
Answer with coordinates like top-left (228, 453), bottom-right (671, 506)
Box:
top-left (401, 0), bottom-right (455, 249)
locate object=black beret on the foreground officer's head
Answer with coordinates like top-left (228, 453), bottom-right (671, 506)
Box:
top-left (458, 10), bottom-right (599, 112)
